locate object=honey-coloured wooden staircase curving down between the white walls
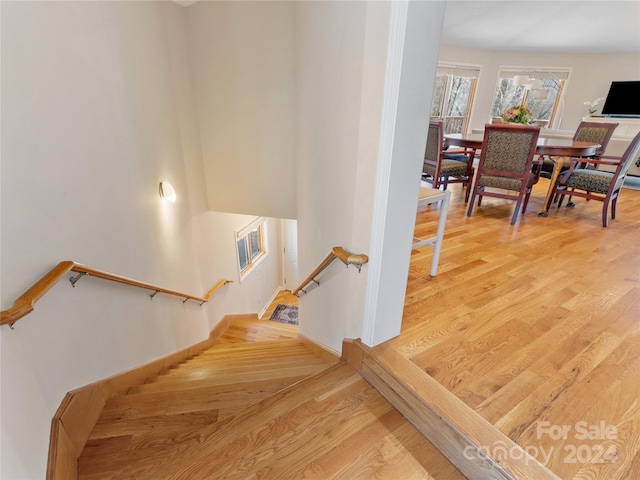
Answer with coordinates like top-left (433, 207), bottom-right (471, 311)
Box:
top-left (78, 316), bottom-right (464, 480)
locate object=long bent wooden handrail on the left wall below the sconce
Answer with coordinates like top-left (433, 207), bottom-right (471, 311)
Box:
top-left (0, 260), bottom-right (231, 325)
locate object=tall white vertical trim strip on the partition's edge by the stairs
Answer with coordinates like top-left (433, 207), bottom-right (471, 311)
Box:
top-left (362, 1), bottom-right (409, 346)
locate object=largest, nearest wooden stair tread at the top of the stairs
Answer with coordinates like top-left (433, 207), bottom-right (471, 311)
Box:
top-left (79, 362), bottom-right (464, 480)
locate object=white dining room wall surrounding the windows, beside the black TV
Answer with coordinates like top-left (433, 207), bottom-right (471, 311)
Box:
top-left (438, 45), bottom-right (640, 131)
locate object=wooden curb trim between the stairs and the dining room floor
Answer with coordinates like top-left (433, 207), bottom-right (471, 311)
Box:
top-left (342, 340), bottom-right (559, 480)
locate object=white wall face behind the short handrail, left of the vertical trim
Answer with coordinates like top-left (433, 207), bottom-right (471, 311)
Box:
top-left (295, 2), bottom-right (370, 351)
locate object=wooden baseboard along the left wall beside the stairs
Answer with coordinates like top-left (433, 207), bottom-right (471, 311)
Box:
top-left (46, 315), bottom-right (239, 480)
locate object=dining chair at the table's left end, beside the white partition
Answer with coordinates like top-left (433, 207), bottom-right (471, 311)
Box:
top-left (422, 120), bottom-right (475, 202)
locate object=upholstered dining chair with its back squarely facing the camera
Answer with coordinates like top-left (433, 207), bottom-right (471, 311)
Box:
top-left (467, 124), bottom-right (540, 225)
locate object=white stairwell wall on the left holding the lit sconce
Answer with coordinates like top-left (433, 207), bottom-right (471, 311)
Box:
top-left (0, 2), bottom-right (281, 480)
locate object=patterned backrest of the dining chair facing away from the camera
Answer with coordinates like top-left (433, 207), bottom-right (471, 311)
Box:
top-left (478, 124), bottom-right (540, 182)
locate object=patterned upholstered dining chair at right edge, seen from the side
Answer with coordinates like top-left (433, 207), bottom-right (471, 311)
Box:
top-left (546, 129), bottom-right (640, 227)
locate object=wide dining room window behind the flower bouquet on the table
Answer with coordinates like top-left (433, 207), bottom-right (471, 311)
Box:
top-left (491, 67), bottom-right (570, 128)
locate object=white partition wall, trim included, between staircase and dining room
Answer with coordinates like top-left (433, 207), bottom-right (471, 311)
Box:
top-left (296, 2), bottom-right (443, 351)
